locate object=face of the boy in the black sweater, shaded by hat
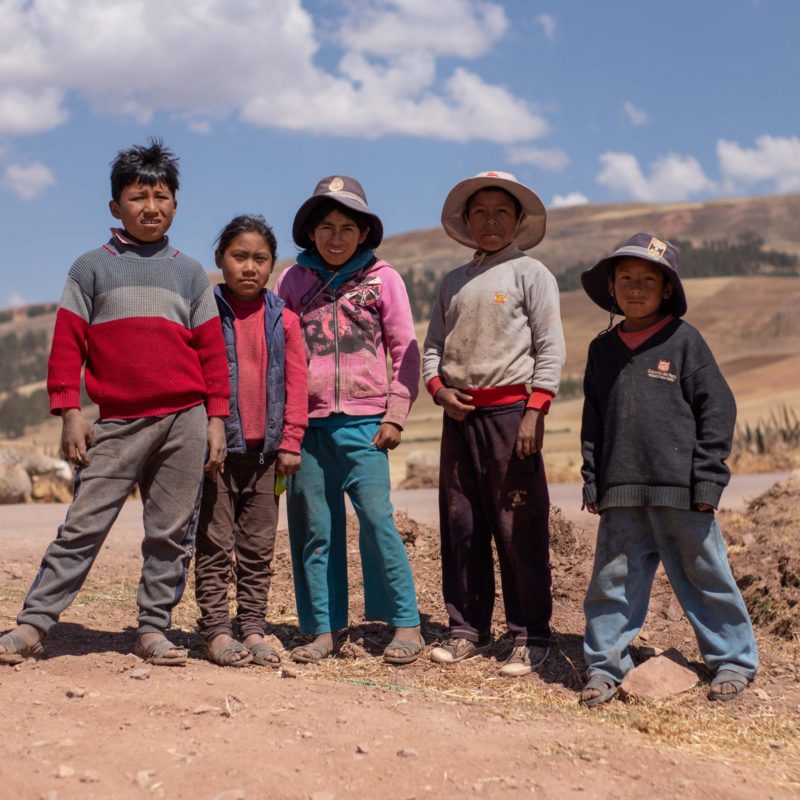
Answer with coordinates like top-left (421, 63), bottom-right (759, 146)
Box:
top-left (608, 257), bottom-right (672, 331)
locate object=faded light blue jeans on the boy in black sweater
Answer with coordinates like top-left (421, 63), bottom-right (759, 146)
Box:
top-left (583, 507), bottom-right (758, 683)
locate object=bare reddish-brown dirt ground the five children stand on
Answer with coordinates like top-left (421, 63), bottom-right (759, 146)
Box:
top-left (0, 484), bottom-right (800, 800)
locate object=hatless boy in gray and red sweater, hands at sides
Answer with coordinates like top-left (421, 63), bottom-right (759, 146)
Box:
top-left (0, 139), bottom-right (230, 666)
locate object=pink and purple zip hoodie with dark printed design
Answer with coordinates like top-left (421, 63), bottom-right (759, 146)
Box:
top-left (275, 261), bottom-right (420, 428)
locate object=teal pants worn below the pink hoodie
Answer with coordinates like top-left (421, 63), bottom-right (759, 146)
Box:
top-left (287, 414), bottom-right (419, 636)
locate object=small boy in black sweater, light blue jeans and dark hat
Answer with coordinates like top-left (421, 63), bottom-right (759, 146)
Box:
top-left (581, 233), bottom-right (758, 706)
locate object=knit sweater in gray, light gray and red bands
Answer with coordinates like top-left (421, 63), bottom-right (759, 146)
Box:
top-left (47, 237), bottom-right (230, 419)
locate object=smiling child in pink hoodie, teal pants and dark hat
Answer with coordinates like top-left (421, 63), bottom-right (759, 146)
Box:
top-left (275, 176), bottom-right (424, 664)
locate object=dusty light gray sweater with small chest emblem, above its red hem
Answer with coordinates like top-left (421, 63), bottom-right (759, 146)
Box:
top-left (422, 244), bottom-right (566, 394)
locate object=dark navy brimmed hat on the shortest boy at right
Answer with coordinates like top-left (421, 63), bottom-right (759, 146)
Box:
top-left (581, 233), bottom-right (687, 317)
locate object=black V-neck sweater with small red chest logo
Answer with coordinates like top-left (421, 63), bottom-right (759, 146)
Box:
top-left (581, 319), bottom-right (736, 511)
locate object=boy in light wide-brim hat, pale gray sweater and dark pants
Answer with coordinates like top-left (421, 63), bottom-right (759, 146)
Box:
top-left (422, 172), bottom-right (565, 676)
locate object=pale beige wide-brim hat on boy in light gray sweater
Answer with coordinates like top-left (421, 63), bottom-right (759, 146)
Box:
top-left (442, 172), bottom-right (547, 250)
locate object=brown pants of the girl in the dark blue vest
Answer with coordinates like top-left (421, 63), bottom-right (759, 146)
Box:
top-left (195, 453), bottom-right (278, 641)
